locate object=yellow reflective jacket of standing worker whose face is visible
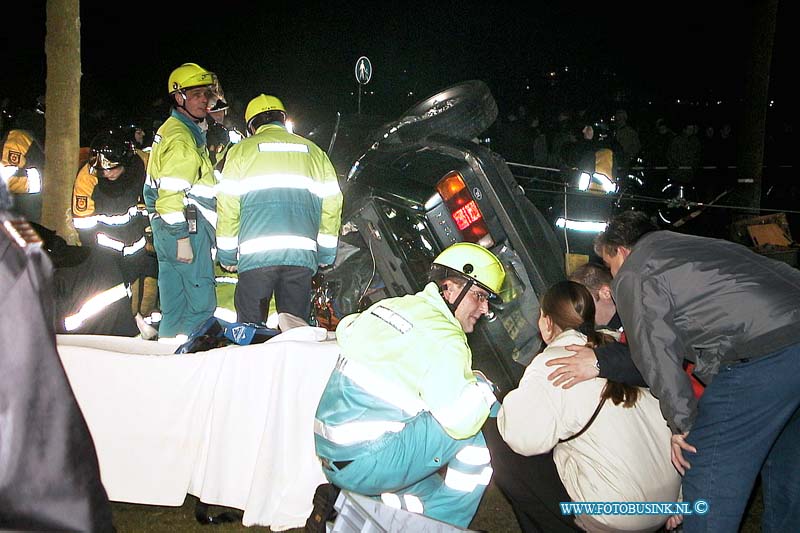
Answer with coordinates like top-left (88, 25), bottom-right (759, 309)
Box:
top-left (144, 110), bottom-right (217, 239)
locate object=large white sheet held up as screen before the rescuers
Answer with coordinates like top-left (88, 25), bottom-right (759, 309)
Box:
top-left (58, 327), bottom-right (339, 531)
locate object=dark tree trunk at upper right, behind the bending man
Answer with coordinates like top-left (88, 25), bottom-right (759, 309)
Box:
top-left (736, 0), bottom-right (778, 209)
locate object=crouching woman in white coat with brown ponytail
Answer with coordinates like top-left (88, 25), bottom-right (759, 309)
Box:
top-left (497, 281), bottom-right (680, 531)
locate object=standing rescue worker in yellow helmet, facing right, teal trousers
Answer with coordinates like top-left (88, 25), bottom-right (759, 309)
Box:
top-left (144, 63), bottom-right (217, 344)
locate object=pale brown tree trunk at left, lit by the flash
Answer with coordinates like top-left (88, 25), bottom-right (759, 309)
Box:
top-left (42, 0), bottom-right (81, 244)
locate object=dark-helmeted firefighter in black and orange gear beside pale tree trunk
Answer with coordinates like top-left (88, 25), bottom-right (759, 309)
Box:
top-left (72, 131), bottom-right (158, 337)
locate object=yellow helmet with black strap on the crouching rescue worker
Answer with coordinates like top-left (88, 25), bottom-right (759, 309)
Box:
top-left (431, 242), bottom-right (506, 298)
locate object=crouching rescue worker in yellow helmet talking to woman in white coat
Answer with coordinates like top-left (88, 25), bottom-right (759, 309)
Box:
top-left (309, 243), bottom-right (505, 527)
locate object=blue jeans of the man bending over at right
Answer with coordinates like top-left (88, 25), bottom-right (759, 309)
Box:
top-left (683, 344), bottom-right (800, 533)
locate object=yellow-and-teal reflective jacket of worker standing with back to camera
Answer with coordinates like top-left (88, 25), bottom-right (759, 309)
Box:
top-left (217, 123), bottom-right (342, 272)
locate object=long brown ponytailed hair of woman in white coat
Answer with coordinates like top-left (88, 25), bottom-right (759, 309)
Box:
top-left (541, 281), bottom-right (640, 407)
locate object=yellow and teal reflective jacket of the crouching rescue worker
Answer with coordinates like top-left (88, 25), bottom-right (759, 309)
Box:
top-left (314, 283), bottom-right (495, 457)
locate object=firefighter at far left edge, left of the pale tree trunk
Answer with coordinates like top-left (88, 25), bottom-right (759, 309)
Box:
top-left (0, 106), bottom-right (44, 222)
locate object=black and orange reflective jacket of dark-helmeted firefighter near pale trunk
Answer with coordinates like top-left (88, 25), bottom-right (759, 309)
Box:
top-left (72, 157), bottom-right (150, 258)
